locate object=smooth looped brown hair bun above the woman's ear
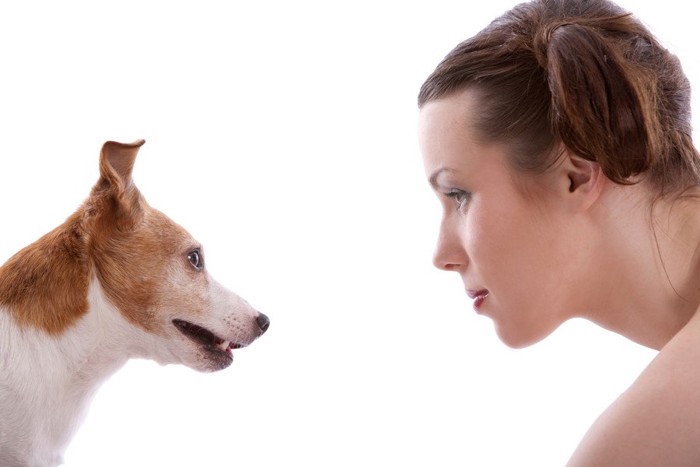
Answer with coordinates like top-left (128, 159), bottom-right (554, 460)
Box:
top-left (547, 23), bottom-right (659, 183)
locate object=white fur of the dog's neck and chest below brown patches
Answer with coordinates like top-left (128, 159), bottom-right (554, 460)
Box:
top-left (0, 277), bottom-right (165, 466)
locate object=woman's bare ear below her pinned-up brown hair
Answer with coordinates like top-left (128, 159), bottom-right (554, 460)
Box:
top-left (558, 149), bottom-right (606, 211)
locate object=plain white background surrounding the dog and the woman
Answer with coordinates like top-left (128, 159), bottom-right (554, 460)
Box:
top-left (0, 0), bottom-right (700, 467)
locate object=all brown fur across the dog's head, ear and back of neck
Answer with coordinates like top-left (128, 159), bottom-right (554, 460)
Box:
top-left (0, 141), bottom-right (170, 334)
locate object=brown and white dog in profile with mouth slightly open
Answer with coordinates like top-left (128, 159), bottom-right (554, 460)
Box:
top-left (0, 140), bottom-right (270, 467)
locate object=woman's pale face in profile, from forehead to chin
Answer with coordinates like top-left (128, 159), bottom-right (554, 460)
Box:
top-left (419, 91), bottom-right (576, 347)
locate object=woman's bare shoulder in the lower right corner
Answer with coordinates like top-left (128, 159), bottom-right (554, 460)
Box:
top-left (568, 313), bottom-right (700, 467)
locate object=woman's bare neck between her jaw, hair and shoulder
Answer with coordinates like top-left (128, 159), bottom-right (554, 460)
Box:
top-left (582, 183), bottom-right (700, 349)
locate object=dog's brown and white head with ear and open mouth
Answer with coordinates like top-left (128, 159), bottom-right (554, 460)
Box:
top-left (82, 141), bottom-right (269, 371)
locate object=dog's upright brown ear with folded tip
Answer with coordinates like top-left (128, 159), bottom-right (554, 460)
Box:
top-left (92, 139), bottom-right (145, 230)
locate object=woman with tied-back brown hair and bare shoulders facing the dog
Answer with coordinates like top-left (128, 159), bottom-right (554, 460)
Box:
top-left (419, 0), bottom-right (700, 466)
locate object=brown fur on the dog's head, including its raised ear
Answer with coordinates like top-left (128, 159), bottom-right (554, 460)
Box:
top-left (89, 141), bottom-right (202, 333)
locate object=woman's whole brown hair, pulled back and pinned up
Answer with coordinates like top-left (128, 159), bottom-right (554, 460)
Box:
top-left (418, 0), bottom-right (700, 194)
